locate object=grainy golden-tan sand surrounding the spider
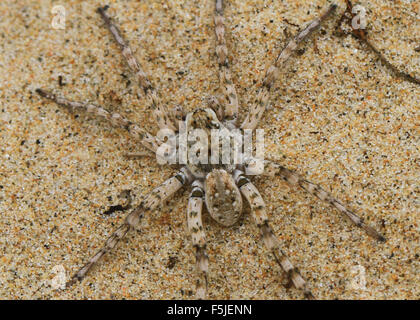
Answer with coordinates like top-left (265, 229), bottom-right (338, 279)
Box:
top-left (0, 0), bottom-right (420, 299)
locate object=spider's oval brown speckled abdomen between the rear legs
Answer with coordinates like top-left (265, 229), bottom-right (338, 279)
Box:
top-left (204, 169), bottom-right (242, 227)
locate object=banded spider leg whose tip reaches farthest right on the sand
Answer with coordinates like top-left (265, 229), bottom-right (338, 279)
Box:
top-left (245, 161), bottom-right (386, 242)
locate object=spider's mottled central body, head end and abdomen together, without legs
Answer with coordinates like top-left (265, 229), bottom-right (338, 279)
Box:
top-left (186, 108), bottom-right (242, 226)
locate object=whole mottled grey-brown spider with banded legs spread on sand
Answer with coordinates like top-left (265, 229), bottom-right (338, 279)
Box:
top-left (36, 0), bottom-right (385, 299)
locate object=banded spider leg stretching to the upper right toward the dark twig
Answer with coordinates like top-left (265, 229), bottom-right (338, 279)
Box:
top-left (241, 4), bottom-right (337, 130)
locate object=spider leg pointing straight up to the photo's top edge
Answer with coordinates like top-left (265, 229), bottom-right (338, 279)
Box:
top-left (214, 0), bottom-right (239, 126)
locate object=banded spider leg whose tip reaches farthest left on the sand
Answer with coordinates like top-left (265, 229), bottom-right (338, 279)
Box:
top-left (36, 89), bottom-right (161, 153)
